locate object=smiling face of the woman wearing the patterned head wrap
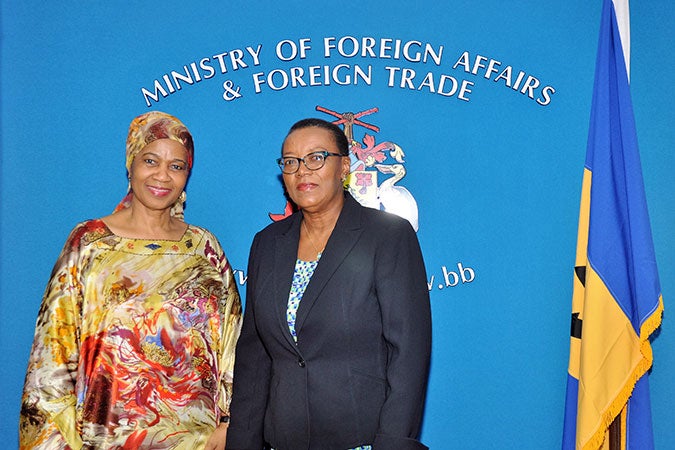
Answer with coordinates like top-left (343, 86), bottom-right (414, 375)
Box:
top-left (130, 139), bottom-right (189, 214)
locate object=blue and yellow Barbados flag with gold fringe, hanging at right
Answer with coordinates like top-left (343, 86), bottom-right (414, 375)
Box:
top-left (562, 0), bottom-right (663, 450)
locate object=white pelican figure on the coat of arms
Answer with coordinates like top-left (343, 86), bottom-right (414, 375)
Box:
top-left (375, 164), bottom-right (419, 232)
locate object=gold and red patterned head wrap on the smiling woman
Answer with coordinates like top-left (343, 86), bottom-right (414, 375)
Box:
top-left (114, 111), bottom-right (194, 220)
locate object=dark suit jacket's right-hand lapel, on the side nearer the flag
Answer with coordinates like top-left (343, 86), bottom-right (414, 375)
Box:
top-left (295, 194), bottom-right (362, 335)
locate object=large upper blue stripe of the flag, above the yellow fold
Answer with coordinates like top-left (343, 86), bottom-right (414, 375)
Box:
top-left (586, 0), bottom-right (660, 335)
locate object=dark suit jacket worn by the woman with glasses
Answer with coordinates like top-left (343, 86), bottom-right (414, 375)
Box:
top-left (227, 194), bottom-right (431, 450)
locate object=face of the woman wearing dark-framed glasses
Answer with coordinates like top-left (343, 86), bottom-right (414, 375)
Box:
top-left (281, 127), bottom-right (349, 212)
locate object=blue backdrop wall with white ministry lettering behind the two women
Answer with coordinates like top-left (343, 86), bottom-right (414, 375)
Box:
top-left (0, 0), bottom-right (675, 449)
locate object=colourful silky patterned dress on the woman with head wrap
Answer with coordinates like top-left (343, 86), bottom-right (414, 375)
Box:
top-left (20, 220), bottom-right (241, 450)
